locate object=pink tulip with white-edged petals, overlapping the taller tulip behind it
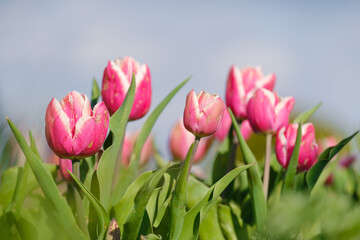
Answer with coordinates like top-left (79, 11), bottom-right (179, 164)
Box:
top-left (247, 88), bottom-right (295, 134)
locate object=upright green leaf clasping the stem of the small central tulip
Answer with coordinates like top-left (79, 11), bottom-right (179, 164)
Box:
top-left (169, 140), bottom-right (194, 240)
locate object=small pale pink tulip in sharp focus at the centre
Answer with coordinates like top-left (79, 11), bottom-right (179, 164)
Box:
top-left (184, 90), bottom-right (225, 137)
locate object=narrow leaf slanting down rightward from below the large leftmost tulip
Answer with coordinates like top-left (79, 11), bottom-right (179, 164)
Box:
top-left (68, 170), bottom-right (110, 239)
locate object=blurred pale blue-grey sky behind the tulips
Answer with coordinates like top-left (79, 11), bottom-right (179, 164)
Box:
top-left (0, 0), bottom-right (360, 160)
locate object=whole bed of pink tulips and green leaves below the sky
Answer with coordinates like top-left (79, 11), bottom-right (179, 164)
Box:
top-left (0, 57), bottom-right (360, 240)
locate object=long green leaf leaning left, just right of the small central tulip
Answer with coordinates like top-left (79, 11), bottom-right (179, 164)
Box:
top-left (228, 108), bottom-right (266, 230)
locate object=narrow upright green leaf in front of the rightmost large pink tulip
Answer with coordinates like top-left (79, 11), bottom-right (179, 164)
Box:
top-left (284, 122), bottom-right (302, 189)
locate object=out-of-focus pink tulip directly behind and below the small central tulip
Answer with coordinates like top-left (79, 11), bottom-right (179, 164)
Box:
top-left (169, 120), bottom-right (211, 164)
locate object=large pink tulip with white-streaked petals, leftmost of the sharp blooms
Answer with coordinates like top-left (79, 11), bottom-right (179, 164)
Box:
top-left (45, 91), bottom-right (110, 159)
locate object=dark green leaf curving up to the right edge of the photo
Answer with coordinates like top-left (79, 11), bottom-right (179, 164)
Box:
top-left (306, 131), bottom-right (359, 190)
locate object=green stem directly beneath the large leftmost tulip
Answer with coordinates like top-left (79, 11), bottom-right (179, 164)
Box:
top-left (73, 159), bottom-right (90, 238)
